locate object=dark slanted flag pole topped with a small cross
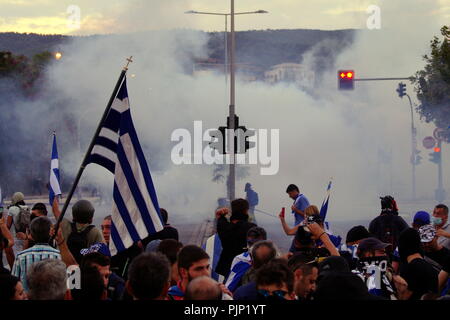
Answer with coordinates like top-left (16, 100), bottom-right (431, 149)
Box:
top-left (50, 56), bottom-right (133, 242)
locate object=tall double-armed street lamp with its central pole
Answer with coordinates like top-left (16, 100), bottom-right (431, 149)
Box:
top-left (185, 5), bottom-right (269, 201)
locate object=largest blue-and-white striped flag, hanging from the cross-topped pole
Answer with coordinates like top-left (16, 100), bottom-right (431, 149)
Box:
top-left (87, 79), bottom-right (163, 256)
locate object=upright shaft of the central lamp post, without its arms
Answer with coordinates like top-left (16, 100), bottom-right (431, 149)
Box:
top-left (228, 0), bottom-right (236, 201)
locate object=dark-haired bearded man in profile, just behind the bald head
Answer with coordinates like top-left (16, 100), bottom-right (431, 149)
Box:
top-left (169, 245), bottom-right (211, 300)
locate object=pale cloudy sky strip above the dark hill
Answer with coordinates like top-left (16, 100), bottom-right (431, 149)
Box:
top-left (0, 0), bottom-right (450, 35)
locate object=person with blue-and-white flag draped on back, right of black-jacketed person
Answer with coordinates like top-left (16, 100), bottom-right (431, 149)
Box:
top-left (225, 227), bottom-right (267, 292)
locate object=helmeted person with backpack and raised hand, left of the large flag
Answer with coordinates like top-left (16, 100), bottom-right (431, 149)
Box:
top-left (52, 199), bottom-right (105, 264)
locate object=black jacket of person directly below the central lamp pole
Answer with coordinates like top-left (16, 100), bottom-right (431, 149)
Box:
top-left (215, 216), bottom-right (256, 277)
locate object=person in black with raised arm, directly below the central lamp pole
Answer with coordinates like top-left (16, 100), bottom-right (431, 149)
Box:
top-left (215, 199), bottom-right (256, 278)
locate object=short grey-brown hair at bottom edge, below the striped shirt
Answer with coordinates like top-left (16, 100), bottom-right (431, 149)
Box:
top-left (27, 259), bottom-right (67, 300)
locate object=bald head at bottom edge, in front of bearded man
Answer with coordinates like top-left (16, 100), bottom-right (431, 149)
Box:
top-left (184, 276), bottom-right (222, 300)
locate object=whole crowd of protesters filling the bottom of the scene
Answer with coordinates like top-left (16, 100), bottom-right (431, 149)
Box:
top-left (0, 184), bottom-right (450, 301)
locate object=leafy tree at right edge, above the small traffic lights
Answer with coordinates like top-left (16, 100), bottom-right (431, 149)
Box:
top-left (413, 26), bottom-right (450, 142)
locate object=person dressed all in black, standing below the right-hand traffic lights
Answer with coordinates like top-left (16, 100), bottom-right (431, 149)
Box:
top-left (369, 196), bottom-right (408, 254)
